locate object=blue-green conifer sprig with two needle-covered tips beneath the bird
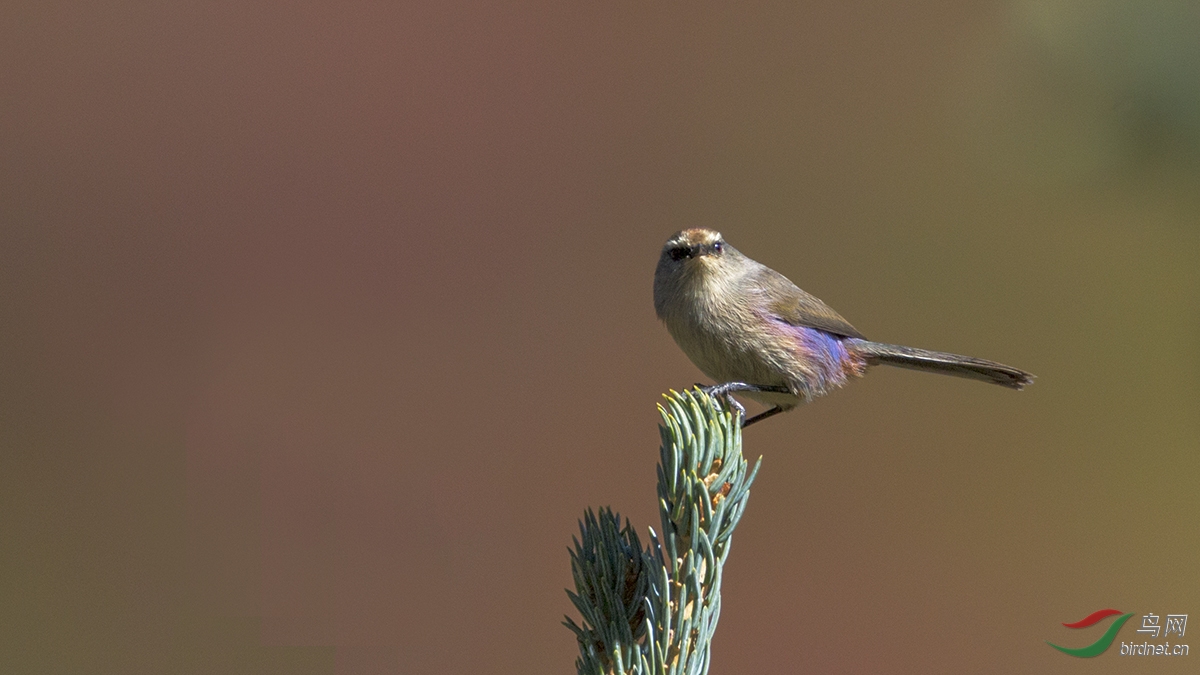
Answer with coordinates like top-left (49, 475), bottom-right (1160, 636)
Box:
top-left (565, 390), bottom-right (762, 675)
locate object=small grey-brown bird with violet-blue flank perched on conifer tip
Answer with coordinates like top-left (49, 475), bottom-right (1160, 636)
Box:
top-left (654, 228), bottom-right (1033, 426)
